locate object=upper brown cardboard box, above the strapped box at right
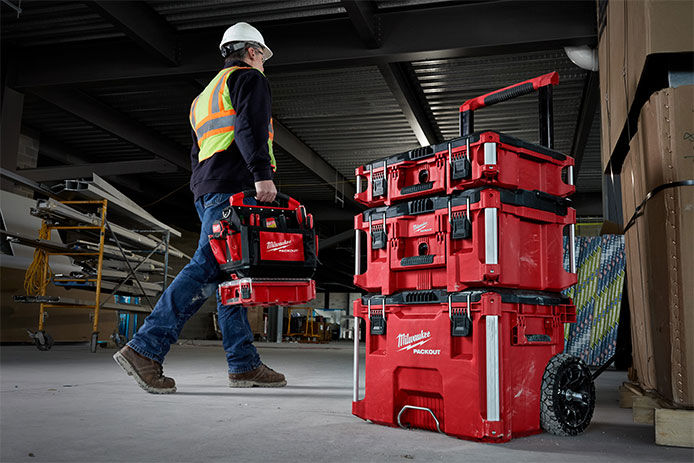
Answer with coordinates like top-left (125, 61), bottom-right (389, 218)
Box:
top-left (598, 0), bottom-right (694, 170)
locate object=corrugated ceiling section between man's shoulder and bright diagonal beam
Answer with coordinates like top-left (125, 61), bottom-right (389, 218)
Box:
top-left (270, 66), bottom-right (419, 180)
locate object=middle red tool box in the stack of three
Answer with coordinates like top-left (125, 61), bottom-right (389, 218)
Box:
top-left (354, 188), bottom-right (576, 294)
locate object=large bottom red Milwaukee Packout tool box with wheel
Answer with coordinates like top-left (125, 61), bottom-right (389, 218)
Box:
top-left (352, 289), bottom-right (595, 442)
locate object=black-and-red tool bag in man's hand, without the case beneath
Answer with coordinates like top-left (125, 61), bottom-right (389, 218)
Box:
top-left (209, 191), bottom-right (318, 279)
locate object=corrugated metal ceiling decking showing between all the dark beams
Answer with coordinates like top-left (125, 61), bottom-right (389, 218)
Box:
top-left (1, 0), bottom-right (602, 228)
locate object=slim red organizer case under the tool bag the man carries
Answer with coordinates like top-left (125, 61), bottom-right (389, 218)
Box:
top-left (219, 278), bottom-right (316, 307)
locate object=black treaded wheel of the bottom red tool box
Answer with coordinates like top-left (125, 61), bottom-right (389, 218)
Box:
top-left (540, 354), bottom-right (595, 436)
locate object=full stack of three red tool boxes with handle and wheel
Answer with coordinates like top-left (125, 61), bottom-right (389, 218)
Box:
top-left (352, 72), bottom-right (595, 442)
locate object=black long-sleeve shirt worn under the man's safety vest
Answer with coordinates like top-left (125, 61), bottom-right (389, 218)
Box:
top-left (190, 61), bottom-right (273, 201)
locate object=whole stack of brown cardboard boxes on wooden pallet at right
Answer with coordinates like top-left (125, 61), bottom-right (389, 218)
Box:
top-left (598, 0), bottom-right (694, 406)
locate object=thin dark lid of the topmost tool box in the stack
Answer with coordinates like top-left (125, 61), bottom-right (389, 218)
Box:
top-left (364, 130), bottom-right (566, 172)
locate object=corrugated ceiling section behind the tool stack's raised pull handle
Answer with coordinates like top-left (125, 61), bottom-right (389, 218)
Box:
top-left (412, 50), bottom-right (600, 191)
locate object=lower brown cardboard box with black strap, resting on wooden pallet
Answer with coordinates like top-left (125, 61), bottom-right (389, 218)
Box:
top-left (622, 86), bottom-right (694, 406)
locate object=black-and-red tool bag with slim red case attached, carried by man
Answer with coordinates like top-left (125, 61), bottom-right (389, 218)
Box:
top-left (209, 191), bottom-right (318, 306)
